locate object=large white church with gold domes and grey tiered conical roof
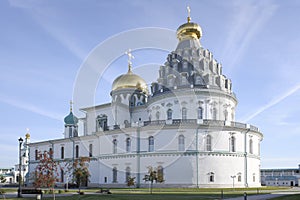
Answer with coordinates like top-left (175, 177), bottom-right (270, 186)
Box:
top-left (28, 10), bottom-right (263, 188)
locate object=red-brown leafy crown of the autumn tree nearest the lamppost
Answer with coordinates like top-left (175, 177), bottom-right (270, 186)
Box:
top-left (33, 151), bottom-right (60, 188)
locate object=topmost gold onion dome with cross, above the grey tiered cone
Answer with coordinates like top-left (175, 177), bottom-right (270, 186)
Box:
top-left (177, 7), bottom-right (202, 40)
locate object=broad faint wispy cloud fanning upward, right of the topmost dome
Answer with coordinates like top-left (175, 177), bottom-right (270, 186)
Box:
top-left (222, 2), bottom-right (278, 71)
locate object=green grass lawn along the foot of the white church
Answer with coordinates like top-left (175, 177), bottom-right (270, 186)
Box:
top-left (0, 187), bottom-right (300, 200)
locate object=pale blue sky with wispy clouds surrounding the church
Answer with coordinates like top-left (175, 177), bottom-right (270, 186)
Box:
top-left (0, 0), bottom-right (300, 168)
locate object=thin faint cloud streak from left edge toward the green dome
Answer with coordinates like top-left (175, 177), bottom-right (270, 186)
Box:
top-left (0, 95), bottom-right (63, 121)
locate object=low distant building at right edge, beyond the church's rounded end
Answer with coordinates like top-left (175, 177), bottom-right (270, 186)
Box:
top-left (260, 165), bottom-right (300, 187)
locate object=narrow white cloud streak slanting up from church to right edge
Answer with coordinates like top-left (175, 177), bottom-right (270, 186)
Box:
top-left (243, 84), bottom-right (300, 122)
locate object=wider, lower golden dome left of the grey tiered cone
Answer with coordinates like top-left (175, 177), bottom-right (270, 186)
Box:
top-left (112, 66), bottom-right (148, 94)
